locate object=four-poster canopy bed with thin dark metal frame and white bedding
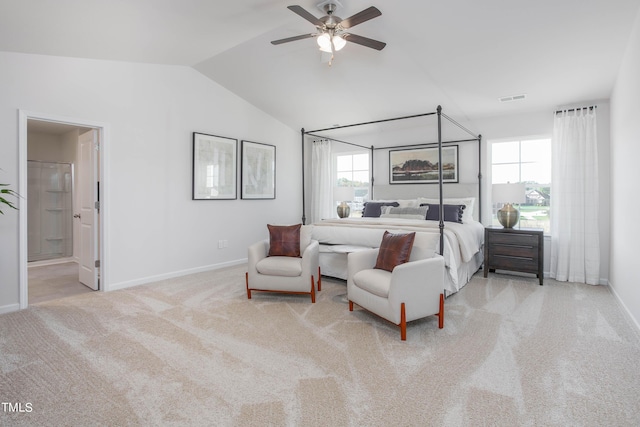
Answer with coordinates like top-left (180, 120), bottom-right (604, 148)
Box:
top-left (301, 106), bottom-right (484, 295)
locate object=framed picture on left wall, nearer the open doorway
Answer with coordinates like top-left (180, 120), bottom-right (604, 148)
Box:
top-left (192, 132), bottom-right (238, 200)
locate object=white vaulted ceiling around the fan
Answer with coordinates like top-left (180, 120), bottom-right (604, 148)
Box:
top-left (0, 0), bottom-right (640, 129)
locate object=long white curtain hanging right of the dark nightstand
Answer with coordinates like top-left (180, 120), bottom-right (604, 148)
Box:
top-left (550, 108), bottom-right (600, 285)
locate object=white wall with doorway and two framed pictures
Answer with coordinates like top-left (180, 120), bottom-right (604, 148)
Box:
top-left (0, 52), bottom-right (301, 312)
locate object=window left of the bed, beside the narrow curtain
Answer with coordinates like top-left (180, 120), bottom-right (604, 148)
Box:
top-left (336, 153), bottom-right (369, 217)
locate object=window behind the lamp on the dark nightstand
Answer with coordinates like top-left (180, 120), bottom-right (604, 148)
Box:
top-left (491, 138), bottom-right (551, 233)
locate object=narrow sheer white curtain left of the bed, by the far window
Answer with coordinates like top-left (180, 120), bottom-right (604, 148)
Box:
top-left (311, 140), bottom-right (335, 224)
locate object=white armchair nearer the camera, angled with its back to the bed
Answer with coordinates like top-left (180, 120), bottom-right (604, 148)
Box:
top-left (347, 249), bottom-right (444, 341)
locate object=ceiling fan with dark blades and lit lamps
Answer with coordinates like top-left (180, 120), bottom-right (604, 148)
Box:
top-left (271, 0), bottom-right (387, 58)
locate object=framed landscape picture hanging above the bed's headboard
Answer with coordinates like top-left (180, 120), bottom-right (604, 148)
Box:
top-left (389, 145), bottom-right (459, 184)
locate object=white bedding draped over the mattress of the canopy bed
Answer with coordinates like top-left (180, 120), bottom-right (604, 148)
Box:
top-left (312, 218), bottom-right (484, 293)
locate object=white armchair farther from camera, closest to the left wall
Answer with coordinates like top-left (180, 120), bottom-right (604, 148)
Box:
top-left (245, 225), bottom-right (322, 303)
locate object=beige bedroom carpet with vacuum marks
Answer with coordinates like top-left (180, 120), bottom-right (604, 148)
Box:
top-left (0, 266), bottom-right (640, 426)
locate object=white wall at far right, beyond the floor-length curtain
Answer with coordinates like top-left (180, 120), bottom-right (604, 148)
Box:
top-left (609, 5), bottom-right (640, 327)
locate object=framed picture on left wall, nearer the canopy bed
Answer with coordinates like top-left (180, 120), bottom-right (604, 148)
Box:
top-left (240, 140), bottom-right (276, 200)
